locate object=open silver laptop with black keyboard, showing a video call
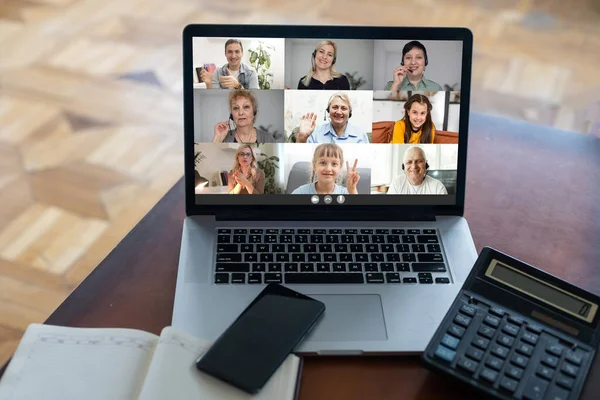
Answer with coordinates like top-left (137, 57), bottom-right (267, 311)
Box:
top-left (172, 25), bottom-right (477, 355)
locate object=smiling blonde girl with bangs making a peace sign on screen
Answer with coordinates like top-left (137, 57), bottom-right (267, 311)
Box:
top-left (292, 143), bottom-right (360, 194)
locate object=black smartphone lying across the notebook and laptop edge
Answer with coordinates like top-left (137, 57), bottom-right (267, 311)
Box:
top-left (196, 283), bottom-right (325, 394)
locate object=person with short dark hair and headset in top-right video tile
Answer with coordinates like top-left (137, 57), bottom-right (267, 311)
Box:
top-left (385, 40), bottom-right (443, 91)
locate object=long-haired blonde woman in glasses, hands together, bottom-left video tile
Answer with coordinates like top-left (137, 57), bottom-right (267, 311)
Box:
top-left (227, 145), bottom-right (265, 194)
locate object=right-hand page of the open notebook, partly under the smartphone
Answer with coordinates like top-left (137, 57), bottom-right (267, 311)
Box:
top-left (140, 327), bottom-right (300, 400)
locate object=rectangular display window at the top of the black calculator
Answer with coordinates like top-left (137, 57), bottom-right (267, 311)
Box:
top-left (485, 260), bottom-right (598, 322)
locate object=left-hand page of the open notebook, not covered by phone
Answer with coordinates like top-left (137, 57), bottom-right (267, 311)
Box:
top-left (0, 324), bottom-right (158, 400)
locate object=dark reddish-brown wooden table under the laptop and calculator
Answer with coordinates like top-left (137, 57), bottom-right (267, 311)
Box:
top-left (1, 114), bottom-right (600, 400)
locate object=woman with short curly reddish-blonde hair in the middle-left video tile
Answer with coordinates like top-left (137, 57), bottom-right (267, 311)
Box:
top-left (213, 89), bottom-right (276, 143)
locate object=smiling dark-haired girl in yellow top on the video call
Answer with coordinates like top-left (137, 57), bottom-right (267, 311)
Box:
top-left (390, 94), bottom-right (435, 144)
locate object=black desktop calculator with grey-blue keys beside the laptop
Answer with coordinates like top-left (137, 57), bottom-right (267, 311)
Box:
top-left (422, 247), bottom-right (600, 400)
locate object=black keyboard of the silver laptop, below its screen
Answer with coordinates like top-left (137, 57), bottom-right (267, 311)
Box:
top-left (215, 228), bottom-right (450, 284)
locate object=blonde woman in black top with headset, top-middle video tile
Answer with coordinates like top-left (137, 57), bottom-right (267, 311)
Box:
top-left (298, 40), bottom-right (350, 90)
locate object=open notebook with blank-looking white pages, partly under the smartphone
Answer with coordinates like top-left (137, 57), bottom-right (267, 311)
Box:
top-left (0, 324), bottom-right (300, 400)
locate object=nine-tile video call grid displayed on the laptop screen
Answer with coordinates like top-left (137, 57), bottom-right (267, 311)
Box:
top-left (192, 37), bottom-right (462, 205)
